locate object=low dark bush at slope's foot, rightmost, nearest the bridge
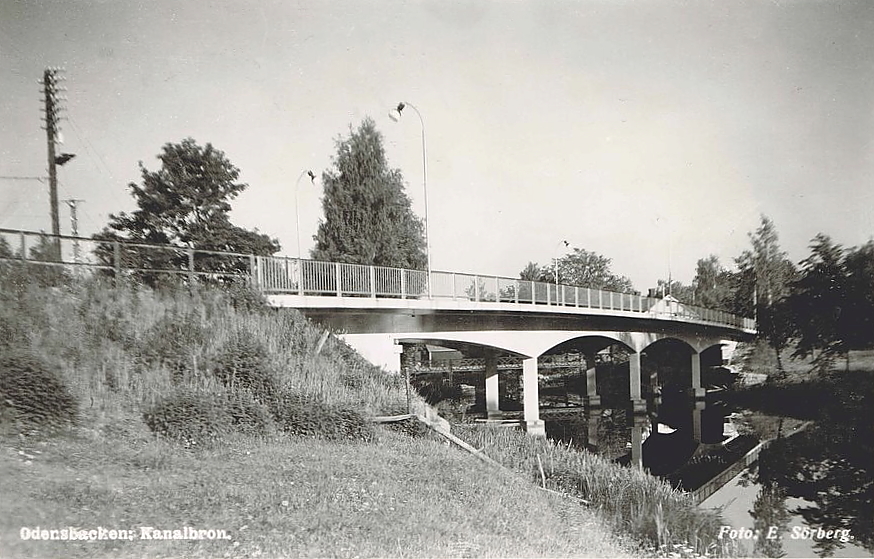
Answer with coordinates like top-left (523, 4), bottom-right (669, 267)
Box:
top-left (270, 392), bottom-right (375, 441)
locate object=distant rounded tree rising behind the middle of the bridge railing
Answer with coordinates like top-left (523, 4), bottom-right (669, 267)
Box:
top-left (532, 247), bottom-right (635, 293)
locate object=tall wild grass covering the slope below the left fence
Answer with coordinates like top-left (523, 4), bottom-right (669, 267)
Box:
top-left (0, 278), bottom-right (406, 434)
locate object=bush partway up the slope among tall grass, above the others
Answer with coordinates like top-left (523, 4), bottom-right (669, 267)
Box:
top-left (213, 330), bottom-right (277, 402)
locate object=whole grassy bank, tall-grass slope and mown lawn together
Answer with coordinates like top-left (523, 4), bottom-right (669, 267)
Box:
top-left (0, 280), bottom-right (635, 557)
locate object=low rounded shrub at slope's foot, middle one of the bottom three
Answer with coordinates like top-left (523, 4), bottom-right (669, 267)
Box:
top-left (143, 389), bottom-right (233, 446)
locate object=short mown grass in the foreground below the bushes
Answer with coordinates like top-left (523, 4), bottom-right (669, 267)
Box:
top-left (0, 418), bottom-right (627, 557)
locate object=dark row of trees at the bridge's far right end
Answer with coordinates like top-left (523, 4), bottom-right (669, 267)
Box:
top-left (670, 216), bottom-right (874, 368)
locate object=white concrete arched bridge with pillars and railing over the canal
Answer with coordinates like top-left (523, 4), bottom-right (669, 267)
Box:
top-left (253, 257), bottom-right (756, 434)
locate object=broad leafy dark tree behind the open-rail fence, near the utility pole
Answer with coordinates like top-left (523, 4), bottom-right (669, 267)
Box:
top-left (94, 138), bottom-right (280, 280)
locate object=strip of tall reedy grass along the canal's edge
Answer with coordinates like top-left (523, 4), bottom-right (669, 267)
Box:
top-left (456, 425), bottom-right (735, 556)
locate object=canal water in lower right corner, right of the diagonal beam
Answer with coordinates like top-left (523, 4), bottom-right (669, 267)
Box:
top-left (701, 384), bottom-right (874, 557)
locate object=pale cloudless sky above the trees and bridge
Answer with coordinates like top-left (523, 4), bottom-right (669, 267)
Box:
top-left (0, 0), bottom-right (874, 293)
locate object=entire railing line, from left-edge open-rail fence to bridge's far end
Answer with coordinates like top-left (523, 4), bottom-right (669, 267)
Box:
top-left (0, 228), bottom-right (756, 332)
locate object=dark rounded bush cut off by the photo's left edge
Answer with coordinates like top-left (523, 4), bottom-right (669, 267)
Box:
top-left (0, 350), bottom-right (78, 425)
